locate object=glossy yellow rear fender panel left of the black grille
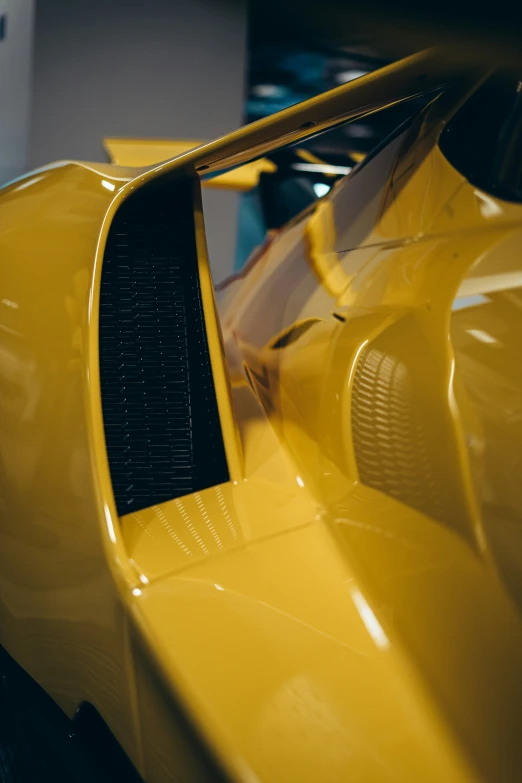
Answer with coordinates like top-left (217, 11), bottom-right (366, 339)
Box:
top-left (0, 163), bottom-right (141, 767)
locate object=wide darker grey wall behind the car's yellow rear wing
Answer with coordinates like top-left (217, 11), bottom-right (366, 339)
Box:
top-left (29, 0), bottom-right (247, 281)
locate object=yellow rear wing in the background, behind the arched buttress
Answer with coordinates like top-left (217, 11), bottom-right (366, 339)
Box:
top-left (103, 138), bottom-right (277, 191)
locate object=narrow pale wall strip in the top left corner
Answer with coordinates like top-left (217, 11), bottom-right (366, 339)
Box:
top-left (0, 0), bottom-right (34, 184)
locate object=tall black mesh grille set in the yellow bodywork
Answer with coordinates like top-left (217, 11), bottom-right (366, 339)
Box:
top-left (100, 181), bottom-right (228, 515)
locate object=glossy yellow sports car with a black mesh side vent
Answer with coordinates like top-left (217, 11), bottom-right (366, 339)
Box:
top-left (0, 51), bottom-right (522, 783)
